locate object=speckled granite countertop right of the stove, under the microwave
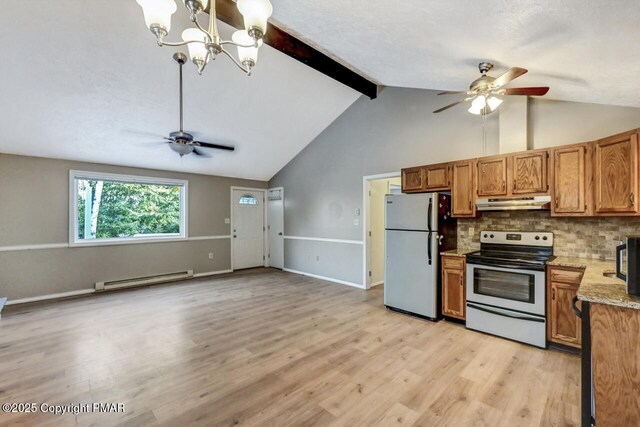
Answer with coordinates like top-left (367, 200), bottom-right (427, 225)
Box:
top-left (547, 257), bottom-right (640, 310)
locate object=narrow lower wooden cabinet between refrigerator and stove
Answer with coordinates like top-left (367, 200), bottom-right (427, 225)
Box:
top-left (442, 255), bottom-right (467, 320)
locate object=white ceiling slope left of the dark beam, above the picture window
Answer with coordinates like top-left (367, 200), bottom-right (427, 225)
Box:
top-left (0, 0), bottom-right (359, 180)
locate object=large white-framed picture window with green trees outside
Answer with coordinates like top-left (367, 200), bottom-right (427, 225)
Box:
top-left (69, 171), bottom-right (188, 245)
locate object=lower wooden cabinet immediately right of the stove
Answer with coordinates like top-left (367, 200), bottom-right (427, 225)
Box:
top-left (547, 267), bottom-right (584, 348)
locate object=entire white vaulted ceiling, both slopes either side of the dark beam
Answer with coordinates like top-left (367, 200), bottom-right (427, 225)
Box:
top-left (0, 0), bottom-right (640, 180)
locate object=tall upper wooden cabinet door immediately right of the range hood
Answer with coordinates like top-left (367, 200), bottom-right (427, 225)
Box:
top-left (551, 143), bottom-right (593, 216)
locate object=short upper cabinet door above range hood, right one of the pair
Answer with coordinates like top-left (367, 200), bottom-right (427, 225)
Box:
top-left (510, 150), bottom-right (549, 195)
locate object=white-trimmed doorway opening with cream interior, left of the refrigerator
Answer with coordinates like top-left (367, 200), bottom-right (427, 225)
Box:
top-left (362, 172), bottom-right (402, 289)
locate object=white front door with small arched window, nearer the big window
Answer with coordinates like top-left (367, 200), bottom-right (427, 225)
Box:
top-left (232, 189), bottom-right (264, 270)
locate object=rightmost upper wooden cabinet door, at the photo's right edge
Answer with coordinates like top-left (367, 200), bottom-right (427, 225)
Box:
top-left (593, 131), bottom-right (638, 215)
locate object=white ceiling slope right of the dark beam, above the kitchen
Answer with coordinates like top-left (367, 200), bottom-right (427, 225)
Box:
top-left (272, 0), bottom-right (640, 107)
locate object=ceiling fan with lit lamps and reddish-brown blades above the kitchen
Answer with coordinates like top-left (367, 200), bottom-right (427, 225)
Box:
top-left (434, 62), bottom-right (549, 116)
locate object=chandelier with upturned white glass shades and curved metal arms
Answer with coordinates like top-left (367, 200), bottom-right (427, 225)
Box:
top-left (136, 0), bottom-right (273, 75)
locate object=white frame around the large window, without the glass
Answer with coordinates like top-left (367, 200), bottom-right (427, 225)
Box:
top-left (69, 170), bottom-right (189, 247)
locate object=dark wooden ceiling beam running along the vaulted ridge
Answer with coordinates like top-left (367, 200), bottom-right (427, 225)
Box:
top-left (210, 0), bottom-right (380, 99)
